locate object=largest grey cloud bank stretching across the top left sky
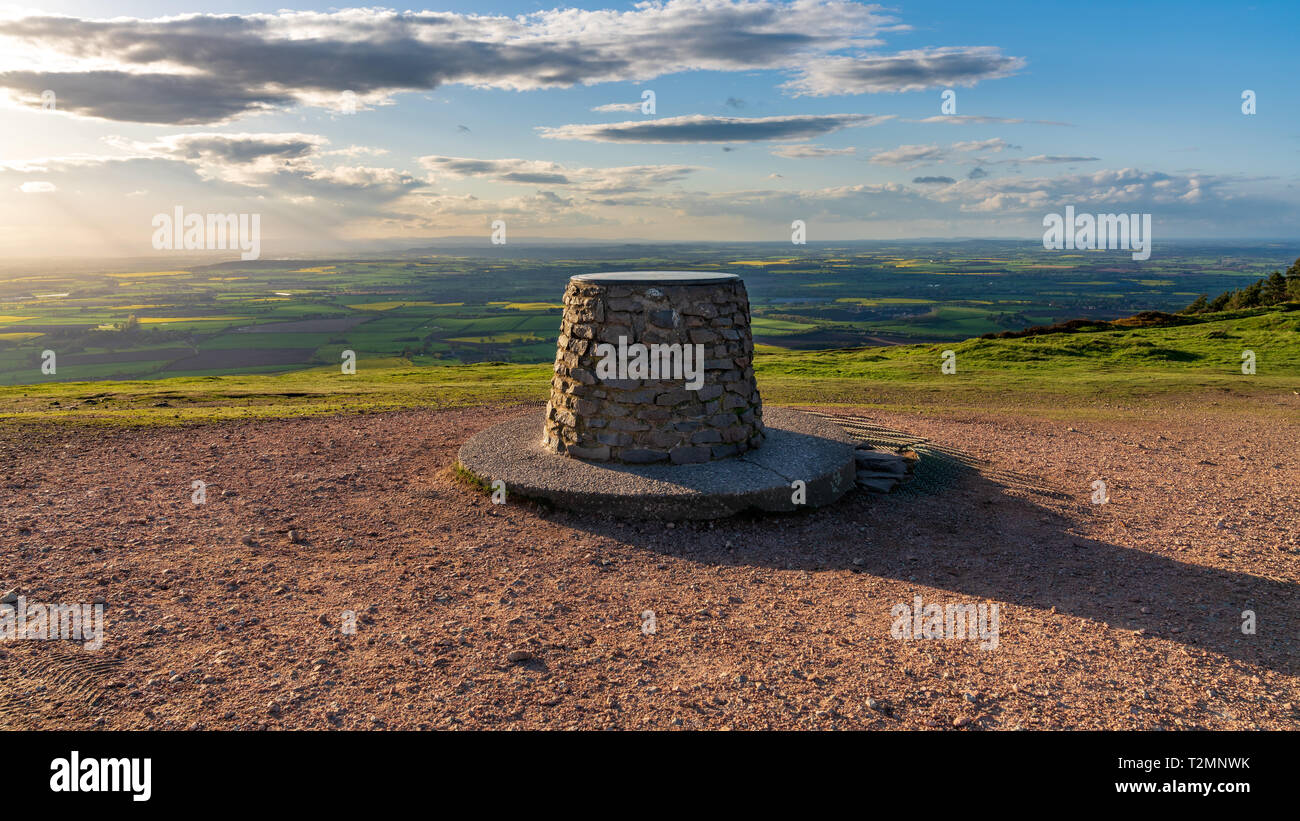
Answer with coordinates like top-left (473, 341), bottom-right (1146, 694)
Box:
top-left (0, 0), bottom-right (1022, 125)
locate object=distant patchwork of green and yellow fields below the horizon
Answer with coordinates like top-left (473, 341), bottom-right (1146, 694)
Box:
top-left (0, 242), bottom-right (1295, 386)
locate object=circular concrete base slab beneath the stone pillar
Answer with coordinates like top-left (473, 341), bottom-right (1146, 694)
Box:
top-left (459, 407), bottom-right (855, 520)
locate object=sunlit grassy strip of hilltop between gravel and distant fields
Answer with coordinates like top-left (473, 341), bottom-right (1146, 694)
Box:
top-left (0, 304), bottom-right (1300, 425)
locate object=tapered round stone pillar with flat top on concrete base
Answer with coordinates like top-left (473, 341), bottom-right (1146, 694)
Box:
top-left (543, 272), bottom-right (763, 464)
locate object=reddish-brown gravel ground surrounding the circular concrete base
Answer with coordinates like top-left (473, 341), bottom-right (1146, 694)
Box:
top-left (0, 407), bottom-right (1300, 731)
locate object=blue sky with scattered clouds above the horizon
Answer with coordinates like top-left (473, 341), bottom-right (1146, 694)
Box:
top-left (0, 0), bottom-right (1300, 255)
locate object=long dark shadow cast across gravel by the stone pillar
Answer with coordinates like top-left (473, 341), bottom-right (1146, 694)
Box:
top-left (546, 470), bottom-right (1300, 676)
